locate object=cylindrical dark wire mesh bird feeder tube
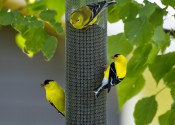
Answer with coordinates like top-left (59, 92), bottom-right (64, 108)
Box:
top-left (66, 0), bottom-right (107, 125)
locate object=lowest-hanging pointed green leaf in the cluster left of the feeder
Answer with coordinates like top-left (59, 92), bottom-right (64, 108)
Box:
top-left (42, 35), bottom-right (57, 61)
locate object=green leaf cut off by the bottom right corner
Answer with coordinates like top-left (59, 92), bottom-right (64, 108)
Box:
top-left (159, 109), bottom-right (175, 125)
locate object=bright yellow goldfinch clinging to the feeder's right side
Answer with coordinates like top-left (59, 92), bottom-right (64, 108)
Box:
top-left (95, 54), bottom-right (127, 97)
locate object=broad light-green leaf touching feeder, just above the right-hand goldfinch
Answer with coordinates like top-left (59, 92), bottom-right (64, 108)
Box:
top-left (108, 33), bottom-right (132, 61)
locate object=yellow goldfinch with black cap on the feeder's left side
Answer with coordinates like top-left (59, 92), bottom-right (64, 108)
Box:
top-left (41, 80), bottom-right (65, 116)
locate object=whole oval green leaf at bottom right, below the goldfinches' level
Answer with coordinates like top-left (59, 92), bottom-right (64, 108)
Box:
top-left (134, 96), bottom-right (157, 125)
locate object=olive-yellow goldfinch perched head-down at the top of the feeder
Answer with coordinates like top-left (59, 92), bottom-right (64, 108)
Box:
top-left (70, 1), bottom-right (116, 29)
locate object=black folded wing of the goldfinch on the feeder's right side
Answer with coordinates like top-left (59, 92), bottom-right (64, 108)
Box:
top-left (108, 62), bottom-right (120, 92)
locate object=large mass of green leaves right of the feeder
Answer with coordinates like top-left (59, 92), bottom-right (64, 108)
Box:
top-left (108, 0), bottom-right (175, 125)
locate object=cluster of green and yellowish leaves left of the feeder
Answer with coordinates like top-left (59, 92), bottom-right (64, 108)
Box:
top-left (0, 0), bottom-right (64, 61)
